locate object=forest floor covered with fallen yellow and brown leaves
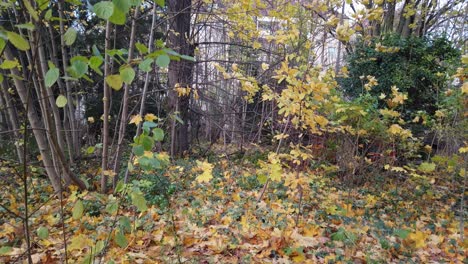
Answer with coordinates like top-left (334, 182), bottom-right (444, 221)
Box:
top-left (0, 145), bottom-right (468, 263)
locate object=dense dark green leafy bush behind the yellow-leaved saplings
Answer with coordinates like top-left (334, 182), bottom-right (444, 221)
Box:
top-left (339, 35), bottom-right (460, 118)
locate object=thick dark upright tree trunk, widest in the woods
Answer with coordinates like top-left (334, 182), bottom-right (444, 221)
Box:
top-left (167, 0), bottom-right (194, 157)
